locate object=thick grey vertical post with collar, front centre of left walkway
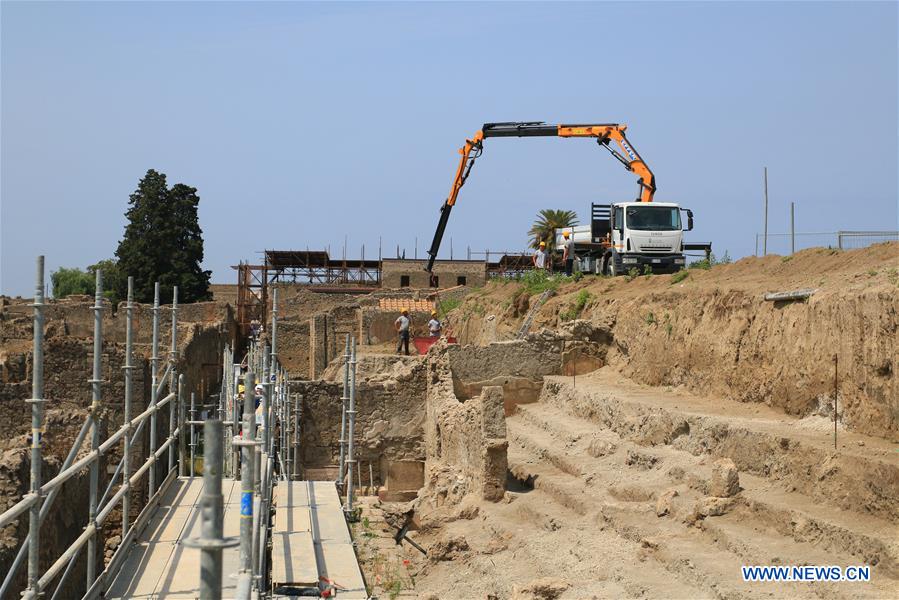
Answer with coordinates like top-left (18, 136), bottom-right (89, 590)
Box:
top-left (200, 420), bottom-right (224, 600)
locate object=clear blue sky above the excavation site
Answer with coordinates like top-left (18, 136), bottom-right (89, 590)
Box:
top-left (0, 2), bottom-right (899, 295)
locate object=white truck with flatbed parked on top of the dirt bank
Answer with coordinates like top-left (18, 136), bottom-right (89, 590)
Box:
top-left (555, 202), bottom-right (712, 276)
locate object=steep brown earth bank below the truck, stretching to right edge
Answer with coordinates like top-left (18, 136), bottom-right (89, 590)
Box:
top-left (452, 242), bottom-right (899, 440)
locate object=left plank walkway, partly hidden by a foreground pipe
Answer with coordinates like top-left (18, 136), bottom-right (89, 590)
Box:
top-left (105, 477), bottom-right (240, 600)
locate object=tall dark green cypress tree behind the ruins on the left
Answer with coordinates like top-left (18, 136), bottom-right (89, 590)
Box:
top-left (116, 169), bottom-right (211, 303)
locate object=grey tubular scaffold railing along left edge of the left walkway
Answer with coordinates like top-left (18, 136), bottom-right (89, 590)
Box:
top-left (0, 256), bottom-right (183, 598)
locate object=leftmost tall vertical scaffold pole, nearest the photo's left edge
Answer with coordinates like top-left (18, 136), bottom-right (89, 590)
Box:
top-left (27, 256), bottom-right (46, 594)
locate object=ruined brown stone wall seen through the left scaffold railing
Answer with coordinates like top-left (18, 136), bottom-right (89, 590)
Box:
top-left (0, 298), bottom-right (235, 597)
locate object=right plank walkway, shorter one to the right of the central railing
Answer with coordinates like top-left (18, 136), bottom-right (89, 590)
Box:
top-left (272, 481), bottom-right (368, 600)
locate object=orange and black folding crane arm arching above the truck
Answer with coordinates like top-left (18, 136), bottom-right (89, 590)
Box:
top-left (426, 121), bottom-right (656, 272)
